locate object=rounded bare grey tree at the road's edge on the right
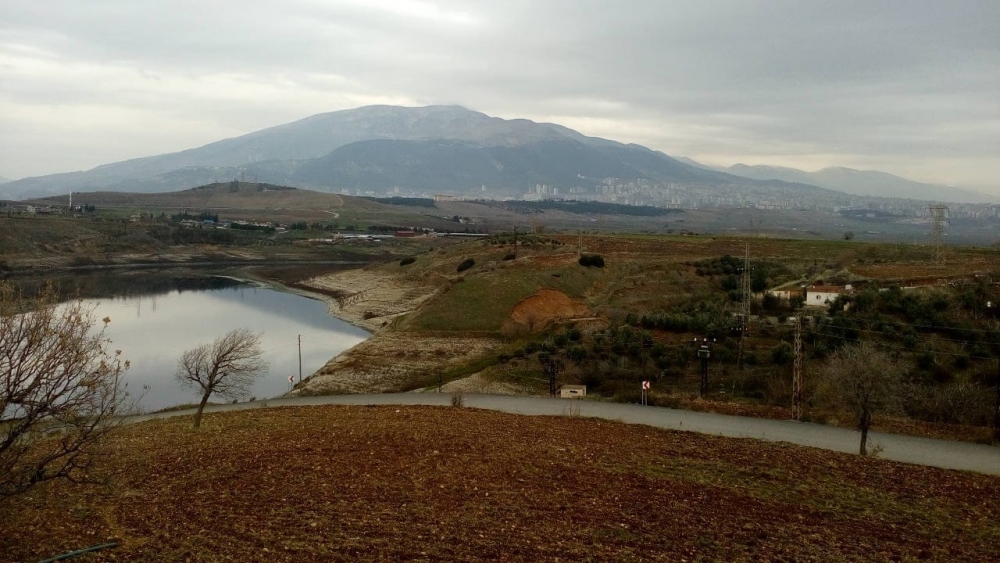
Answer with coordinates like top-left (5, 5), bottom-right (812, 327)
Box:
top-left (824, 342), bottom-right (903, 455)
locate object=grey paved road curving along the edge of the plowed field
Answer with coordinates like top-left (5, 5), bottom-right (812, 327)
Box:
top-left (132, 393), bottom-right (1000, 475)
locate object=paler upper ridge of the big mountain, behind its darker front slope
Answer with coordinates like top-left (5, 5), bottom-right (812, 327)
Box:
top-left (0, 106), bottom-right (614, 197)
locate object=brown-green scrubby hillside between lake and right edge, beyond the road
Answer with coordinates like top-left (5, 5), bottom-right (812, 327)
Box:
top-left (292, 233), bottom-right (1000, 448)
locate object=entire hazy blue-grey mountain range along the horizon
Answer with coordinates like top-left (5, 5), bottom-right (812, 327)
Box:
top-left (0, 106), bottom-right (989, 202)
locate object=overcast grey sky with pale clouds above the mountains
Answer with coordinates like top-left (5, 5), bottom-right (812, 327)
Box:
top-left (0, 0), bottom-right (1000, 193)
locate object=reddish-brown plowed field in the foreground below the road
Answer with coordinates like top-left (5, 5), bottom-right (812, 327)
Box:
top-left (0, 407), bottom-right (1000, 562)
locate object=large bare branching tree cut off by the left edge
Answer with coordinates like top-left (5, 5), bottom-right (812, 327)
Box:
top-left (0, 283), bottom-right (128, 497)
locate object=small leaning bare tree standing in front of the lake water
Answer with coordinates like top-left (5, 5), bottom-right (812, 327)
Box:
top-left (176, 328), bottom-right (268, 428)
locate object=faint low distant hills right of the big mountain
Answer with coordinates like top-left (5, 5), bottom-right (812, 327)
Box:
top-left (719, 164), bottom-right (998, 203)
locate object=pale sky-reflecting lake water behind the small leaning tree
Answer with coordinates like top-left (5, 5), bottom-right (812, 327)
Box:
top-left (77, 285), bottom-right (369, 411)
